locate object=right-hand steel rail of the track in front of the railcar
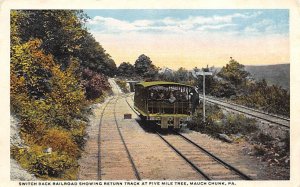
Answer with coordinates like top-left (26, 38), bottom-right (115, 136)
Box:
top-left (173, 130), bottom-right (252, 180)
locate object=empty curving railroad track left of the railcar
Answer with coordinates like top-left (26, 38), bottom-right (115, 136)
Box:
top-left (97, 87), bottom-right (141, 180)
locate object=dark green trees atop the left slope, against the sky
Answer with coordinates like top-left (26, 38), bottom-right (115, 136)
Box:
top-left (11, 10), bottom-right (116, 75)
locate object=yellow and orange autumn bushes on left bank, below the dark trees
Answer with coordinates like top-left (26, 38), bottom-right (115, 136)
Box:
top-left (11, 40), bottom-right (86, 177)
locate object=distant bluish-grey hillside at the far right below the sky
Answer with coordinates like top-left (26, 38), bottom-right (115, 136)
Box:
top-left (245, 64), bottom-right (290, 90)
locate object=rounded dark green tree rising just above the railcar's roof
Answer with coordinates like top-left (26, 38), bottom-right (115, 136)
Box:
top-left (134, 54), bottom-right (158, 79)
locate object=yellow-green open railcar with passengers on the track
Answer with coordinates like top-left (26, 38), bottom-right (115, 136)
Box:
top-left (134, 81), bottom-right (199, 129)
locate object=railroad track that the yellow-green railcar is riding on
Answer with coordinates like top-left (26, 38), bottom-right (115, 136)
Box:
top-left (125, 97), bottom-right (252, 180)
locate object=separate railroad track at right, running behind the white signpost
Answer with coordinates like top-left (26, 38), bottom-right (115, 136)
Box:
top-left (200, 96), bottom-right (290, 128)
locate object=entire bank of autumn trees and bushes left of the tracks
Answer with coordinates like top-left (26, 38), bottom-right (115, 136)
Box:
top-left (10, 10), bottom-right (116, 180)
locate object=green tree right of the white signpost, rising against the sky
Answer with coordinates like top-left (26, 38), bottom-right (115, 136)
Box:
top-left (218, 57), bottom-right (250, 86)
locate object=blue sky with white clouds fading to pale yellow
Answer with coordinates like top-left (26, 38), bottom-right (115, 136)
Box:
top-left (84, 9), bottom-right (289, 69)
